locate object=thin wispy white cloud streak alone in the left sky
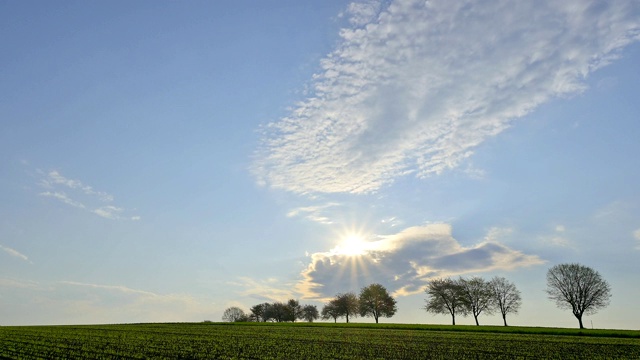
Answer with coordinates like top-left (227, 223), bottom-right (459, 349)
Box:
top-left (38, 170), bottom-right (140, 221)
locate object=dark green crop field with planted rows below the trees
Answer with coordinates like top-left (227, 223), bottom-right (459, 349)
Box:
top-left (0, 323), bottom-right (640, 359)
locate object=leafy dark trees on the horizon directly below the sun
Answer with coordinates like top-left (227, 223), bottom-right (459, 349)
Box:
top-left (322, 284), bottom-right (398, 324)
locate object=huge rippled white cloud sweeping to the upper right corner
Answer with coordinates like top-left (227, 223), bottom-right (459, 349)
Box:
top-left (253, 0), bottom-right (640, 194)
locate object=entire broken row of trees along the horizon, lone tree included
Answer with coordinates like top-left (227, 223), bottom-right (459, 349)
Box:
top-left (222, 264), bottom-right (611, 329)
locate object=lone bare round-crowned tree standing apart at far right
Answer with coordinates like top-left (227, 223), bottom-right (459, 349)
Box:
top-left (546, 264), bottom-right (611, 329)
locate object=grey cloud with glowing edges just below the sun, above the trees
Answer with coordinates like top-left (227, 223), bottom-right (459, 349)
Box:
top-left (297, 224), bottom-right (544, 299)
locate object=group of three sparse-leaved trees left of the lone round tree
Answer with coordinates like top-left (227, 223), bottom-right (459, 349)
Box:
top-left (425, 276), bottom-right (522, 326)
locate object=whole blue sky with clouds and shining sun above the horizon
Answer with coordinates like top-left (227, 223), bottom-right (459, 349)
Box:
top-left (0, 0), bottom-right (640, 329)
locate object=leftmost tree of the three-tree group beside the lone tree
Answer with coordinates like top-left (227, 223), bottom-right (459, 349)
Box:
top-left (425, 278), bottom-right (467, 325)
